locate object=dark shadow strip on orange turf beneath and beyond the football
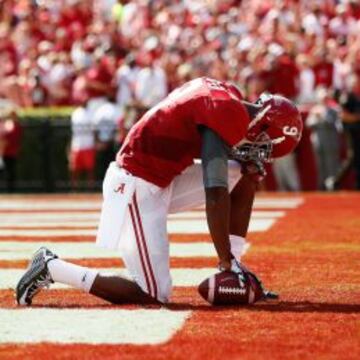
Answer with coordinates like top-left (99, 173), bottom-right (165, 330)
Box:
top-left (167, 301), bottom-right (360, 314)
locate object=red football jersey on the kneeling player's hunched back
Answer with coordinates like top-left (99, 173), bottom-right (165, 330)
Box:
top-left (117, 78), bottom-right (250, 187)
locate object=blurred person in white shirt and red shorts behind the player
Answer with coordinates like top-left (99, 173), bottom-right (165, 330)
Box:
top-left (69, 102), bottom-right (95, 189)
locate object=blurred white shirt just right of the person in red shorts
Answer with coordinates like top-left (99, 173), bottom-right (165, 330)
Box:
top-left (92, 101), bottom-right (124, 142)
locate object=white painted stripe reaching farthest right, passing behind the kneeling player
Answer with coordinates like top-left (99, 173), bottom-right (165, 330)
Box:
top-left (0, 197), bottom-right (303, 211)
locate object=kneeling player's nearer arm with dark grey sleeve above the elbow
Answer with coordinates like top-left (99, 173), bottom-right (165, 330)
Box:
top-left (201, 127), bottom-right (232, 269)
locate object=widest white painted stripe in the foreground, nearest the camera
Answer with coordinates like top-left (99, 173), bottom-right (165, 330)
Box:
top-left (0, 308), bottom-right (191, 345)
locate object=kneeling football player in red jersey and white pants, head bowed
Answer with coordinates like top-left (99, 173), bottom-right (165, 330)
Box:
top-left (16, 78), bottom-right (302, 305)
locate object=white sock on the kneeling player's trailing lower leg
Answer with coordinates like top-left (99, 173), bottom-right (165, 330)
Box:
top-left (47, 259), bottom-right (98, 292)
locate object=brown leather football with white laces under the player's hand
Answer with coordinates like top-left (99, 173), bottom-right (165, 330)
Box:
top-left (198, 271), bottom-right (264, 305)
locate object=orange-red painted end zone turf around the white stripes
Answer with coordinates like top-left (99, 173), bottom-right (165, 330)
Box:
top-left (0, 193), bottom-right (360, 359)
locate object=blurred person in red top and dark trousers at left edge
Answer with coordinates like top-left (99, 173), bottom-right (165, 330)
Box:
top-left (0, 100), bottom-right (22, 193)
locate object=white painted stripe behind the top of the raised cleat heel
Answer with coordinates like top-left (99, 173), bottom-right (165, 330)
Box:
top-left (0, 241), bottom-right (216, 260)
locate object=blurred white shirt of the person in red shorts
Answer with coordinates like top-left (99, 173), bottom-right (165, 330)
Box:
top-left (71, 106), bottom-right (95, 151)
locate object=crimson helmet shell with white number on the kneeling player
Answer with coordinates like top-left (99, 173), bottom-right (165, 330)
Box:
top-left (246, 93), bottom-right (303, 158)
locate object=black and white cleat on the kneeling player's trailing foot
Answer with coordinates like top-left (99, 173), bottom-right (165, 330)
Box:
top-left (15, 247), bottom-right (57, 305)
